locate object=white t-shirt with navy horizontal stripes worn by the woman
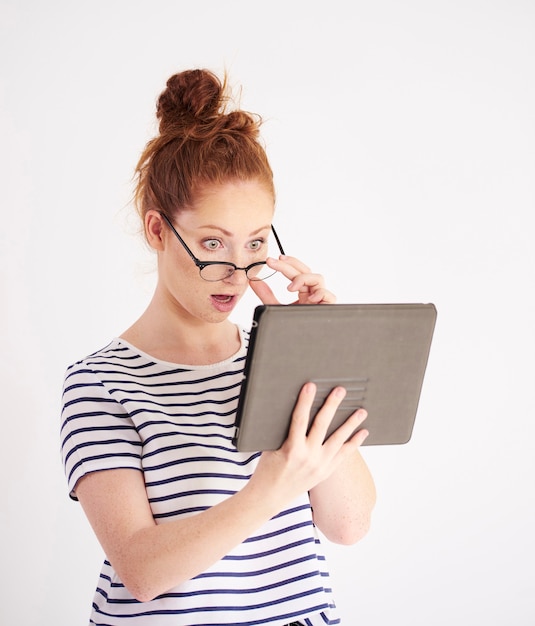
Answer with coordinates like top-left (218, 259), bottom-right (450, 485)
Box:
top-left (61, 329), bottom-right (340, 626)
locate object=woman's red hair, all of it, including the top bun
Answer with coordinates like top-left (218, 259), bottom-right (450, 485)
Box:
top-left (134, 70), bottom-right (275, 228)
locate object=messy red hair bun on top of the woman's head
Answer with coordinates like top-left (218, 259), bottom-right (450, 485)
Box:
top-left (156, 70), bottom-right (224, 133)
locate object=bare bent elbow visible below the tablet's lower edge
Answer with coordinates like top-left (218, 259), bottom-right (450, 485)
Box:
top-left (310, 452), bottom-right (376, 545)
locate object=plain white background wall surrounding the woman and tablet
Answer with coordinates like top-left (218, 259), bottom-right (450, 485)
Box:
top-left (0, 0), bottom-right (535, 626)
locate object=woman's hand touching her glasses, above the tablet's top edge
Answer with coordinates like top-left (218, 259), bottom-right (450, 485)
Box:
top-left (249, 255), bottom-right (336, 304)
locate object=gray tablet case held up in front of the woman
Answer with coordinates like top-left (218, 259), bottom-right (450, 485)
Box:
top-left (233, 304), bottom-right (437, 451)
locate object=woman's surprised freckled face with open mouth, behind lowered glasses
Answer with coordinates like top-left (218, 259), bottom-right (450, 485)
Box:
top-left (153, 176), bottom-right (274, 322)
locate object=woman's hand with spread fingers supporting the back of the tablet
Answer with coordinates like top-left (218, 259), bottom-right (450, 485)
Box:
top-left (249, 383), bottom-right (368, 508)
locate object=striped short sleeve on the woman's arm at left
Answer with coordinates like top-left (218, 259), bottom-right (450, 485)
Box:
top-left (61, 362), bottom-right (142, 500)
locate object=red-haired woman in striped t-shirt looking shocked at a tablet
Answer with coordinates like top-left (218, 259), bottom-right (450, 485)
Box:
top-left (62, 70), bottom-right (375, 626)
